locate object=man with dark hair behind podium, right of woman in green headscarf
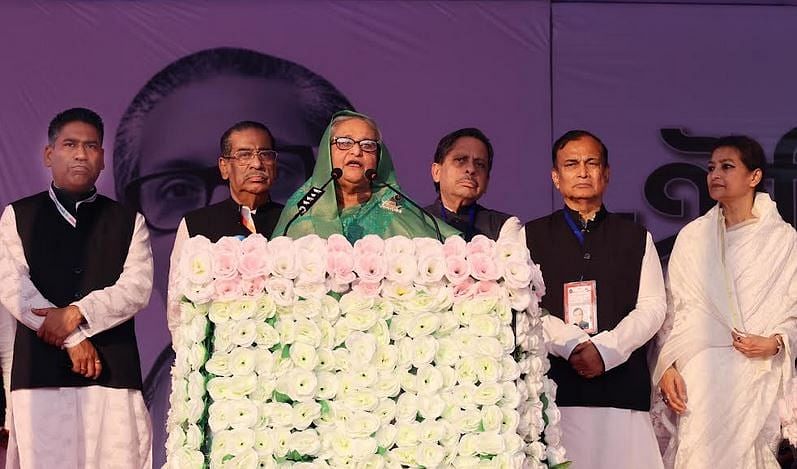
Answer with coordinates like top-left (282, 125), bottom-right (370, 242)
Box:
top-left (426, 128), bottom-right (510, 241)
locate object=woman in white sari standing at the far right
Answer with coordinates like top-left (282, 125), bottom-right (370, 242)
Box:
top-left (653, 136), bottom-right (797, 469)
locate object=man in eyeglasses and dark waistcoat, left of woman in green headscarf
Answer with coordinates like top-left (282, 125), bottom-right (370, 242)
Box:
top-left (167, 121), bottom-right (283, 335)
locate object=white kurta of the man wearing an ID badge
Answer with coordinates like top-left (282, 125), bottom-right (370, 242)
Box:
top-left (542, 233), bottom-right (666, 469)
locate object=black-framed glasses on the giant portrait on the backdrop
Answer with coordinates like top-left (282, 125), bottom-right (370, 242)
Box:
top-left (124, 145), bottom-right (315, 233)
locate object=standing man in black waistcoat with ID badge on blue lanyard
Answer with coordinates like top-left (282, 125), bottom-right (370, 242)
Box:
top-left (526, 130), bottom-right (666, 469)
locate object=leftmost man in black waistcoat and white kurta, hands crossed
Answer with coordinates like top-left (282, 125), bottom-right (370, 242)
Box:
top-left (0, 108), bottom-right (152, 468)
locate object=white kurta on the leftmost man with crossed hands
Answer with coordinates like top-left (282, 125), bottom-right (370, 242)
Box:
top-left (0, 197), bottom-right (153, 469)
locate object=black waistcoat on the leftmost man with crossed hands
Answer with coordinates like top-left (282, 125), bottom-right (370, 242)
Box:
top-left (11, 192), bottom-right (141, 390)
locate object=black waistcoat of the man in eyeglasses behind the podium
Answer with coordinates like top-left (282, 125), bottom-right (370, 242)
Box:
top-left (185, 198), bottom-right (283, 243)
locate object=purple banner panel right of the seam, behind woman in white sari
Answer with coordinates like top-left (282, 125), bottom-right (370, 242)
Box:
top-left (551, 3), bottom-right (797, 257)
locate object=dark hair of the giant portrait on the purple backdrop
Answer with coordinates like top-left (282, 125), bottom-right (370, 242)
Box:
top-left (113, 47), bottom-right (354, 200)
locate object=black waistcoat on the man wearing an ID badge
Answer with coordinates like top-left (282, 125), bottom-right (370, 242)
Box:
top-left (526, 209), bottom-right (650, 410)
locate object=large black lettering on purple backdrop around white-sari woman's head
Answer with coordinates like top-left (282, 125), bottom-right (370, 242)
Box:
top-left (644, 127), bottom-right (797, 259)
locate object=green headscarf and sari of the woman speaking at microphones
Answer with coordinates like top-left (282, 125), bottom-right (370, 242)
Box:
top-left (272, 111), bottom-right (459, 243)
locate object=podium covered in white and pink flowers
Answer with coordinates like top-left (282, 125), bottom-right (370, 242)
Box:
top-left (167, 225), bottom-right (565, 469)
